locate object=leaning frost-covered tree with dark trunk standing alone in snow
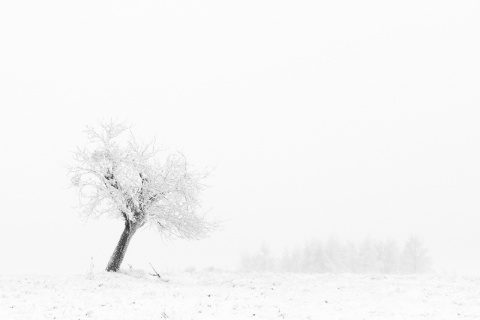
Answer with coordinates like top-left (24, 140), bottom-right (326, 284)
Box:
top-left (71, 122), bottom-right (215, 272)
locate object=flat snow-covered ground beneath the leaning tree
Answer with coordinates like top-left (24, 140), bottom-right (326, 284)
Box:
top-left (0, 272), bottom-right (480, 320)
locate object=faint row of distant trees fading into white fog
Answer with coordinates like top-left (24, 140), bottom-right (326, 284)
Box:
top-left (240, 236), bottom-right (432, 274)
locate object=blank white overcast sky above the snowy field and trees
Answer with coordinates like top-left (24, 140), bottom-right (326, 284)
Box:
top-left (0, 0), bottom-right (480, 274)
